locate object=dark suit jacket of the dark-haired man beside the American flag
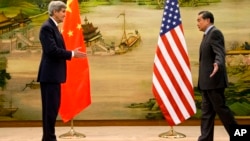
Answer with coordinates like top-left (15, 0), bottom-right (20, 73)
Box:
top-left (198, 27), bottom-right (228, 90)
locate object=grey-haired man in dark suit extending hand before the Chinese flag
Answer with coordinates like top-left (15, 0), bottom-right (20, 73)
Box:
top-left (37, 1), bottom-right (86, 141)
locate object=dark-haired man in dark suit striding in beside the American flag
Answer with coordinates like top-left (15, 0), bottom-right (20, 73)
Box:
top-left (197, 11), bottom-right (236, 141)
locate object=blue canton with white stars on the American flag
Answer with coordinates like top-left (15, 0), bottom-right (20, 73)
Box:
top-left (160, 0), bottom-right (181, 35)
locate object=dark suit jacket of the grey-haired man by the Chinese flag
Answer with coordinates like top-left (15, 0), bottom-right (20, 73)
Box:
top-left (37, 18), bottom-right (72, 83)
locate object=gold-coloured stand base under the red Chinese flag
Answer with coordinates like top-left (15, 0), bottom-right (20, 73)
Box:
top-left (59, 120), bottom-right (86, 139)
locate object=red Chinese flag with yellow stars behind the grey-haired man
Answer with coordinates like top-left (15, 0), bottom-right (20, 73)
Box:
top-left (59, 0), bottom-right (91, 122)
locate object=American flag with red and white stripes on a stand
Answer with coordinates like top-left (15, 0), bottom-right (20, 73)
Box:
top-left (153, 0), bottom-right (196, 126)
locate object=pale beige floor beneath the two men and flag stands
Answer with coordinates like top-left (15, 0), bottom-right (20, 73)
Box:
top-left (0, 126), bottom-right (229, 141)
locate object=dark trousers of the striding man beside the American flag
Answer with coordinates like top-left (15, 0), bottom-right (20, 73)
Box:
top-left (198, 88), bottom-right (237, 141)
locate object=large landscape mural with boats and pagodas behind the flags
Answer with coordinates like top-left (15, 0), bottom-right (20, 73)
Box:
top-left (0, 0), bottom-right (250, 121)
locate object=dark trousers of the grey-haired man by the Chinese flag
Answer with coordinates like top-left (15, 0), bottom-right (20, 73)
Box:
top-left (40, 82), bottom-right (61, 141)
